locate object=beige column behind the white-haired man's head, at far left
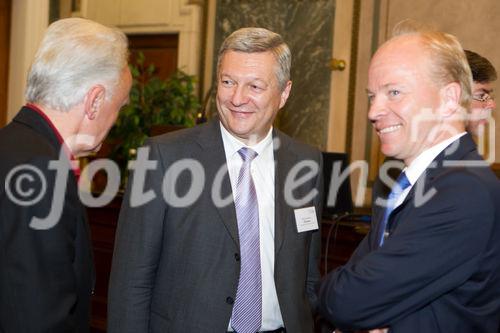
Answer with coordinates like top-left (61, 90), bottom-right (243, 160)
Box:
top-left (7, 0), bottom-right (49, 121)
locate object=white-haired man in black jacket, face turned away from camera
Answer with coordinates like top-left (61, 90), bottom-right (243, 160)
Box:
top-left (0, 18), bottom-right (131, 333)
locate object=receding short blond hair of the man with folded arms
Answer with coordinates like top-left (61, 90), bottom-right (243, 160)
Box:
top-left (393, 20), bottom-right (472, 109)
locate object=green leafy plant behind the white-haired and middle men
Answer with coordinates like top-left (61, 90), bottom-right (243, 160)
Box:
top-left (108, 53), bottom-right (200, 179)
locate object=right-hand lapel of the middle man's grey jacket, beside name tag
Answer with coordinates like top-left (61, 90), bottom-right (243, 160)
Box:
top-left (273, 130), bottom-right (297, 254)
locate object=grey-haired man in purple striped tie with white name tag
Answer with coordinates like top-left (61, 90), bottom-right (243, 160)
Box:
top-left (108, 28), bottom-right (321, 333)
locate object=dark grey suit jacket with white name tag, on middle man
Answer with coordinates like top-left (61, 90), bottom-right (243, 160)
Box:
top-left (108, 121), bottom-right (321, 333)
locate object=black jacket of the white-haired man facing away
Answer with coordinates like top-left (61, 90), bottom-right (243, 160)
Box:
top-left (0, 107), bottom-right (93, 333)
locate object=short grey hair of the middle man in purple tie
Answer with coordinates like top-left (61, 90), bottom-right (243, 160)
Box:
top-left (217, 28), bottom-right (292, 90)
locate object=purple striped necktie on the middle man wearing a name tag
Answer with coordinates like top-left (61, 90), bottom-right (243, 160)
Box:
top-left (231, 147), bottom-right (262, 333)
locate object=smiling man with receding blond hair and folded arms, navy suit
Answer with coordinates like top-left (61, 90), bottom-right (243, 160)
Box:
top-left (319, 22), bottom-right (500, 333)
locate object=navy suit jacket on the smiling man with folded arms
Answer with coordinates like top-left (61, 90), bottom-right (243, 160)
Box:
top-left (320, 135), bottom-right (500, 333)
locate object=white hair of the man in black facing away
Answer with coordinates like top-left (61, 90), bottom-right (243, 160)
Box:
top-left (25, 18), bottom-right (128, 111)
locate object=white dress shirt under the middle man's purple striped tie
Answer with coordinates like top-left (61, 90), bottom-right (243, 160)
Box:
top-left (220, 124), bottom-right (284, 331)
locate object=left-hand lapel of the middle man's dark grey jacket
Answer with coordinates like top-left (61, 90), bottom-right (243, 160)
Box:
top-left (196, 119), bottom-right (240, 248)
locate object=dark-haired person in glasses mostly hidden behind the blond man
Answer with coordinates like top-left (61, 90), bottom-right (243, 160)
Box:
top-left (465, 50), bottom-right (497, 137)
